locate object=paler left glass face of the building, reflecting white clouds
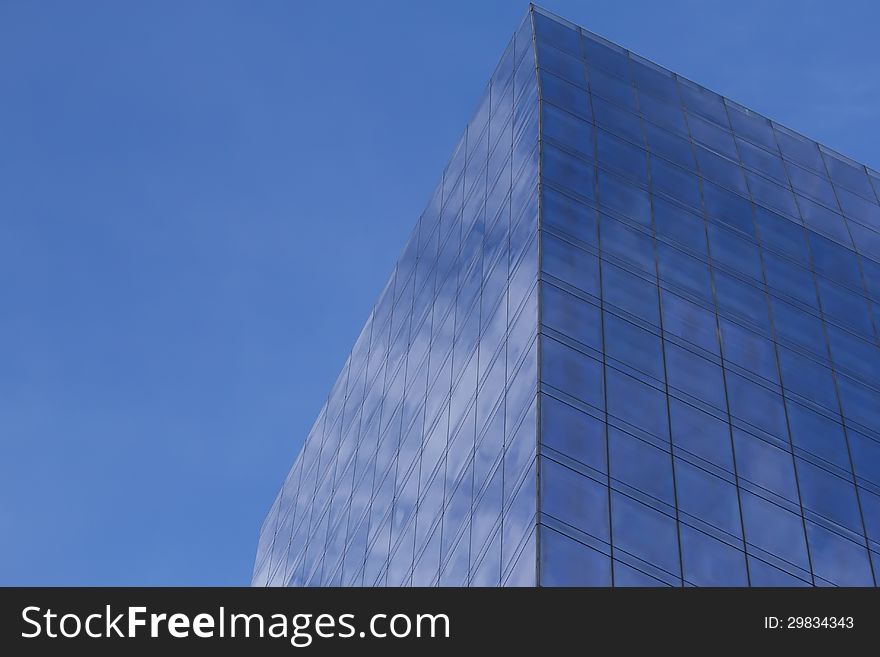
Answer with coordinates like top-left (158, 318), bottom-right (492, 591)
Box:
top-left (253, 9), bottom-right (540, 586)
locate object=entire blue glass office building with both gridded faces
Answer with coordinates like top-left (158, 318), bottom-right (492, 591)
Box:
top-left (253, 8), bottom-right (880, 586)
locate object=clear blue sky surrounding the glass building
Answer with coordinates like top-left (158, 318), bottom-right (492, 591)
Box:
top-left (0, 0), bottom-right (880, 585)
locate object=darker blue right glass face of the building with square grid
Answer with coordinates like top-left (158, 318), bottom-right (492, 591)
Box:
top-left (535, 10), bottom-right (880, 586)
